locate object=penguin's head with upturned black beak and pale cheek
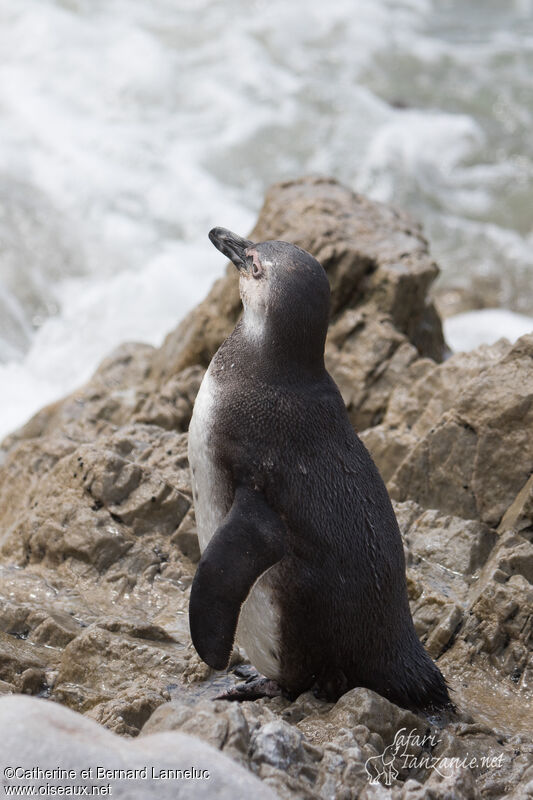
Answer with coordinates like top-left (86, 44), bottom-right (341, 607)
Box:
top-left (209, 228), bottom-right (330, 360)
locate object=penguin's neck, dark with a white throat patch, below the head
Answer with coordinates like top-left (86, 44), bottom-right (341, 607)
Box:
top-left (235, 309), bottom-right (325, 381)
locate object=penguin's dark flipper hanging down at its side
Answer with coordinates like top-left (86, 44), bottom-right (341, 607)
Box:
top-left (189, 487), bottom-right (285, 669)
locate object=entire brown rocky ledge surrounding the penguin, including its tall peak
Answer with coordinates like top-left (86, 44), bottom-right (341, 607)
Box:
top-left (0, 178), bottom-right (533, 800)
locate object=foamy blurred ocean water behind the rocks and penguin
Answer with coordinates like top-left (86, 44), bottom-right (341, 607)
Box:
top-left (0, 0), bottom-right (533, 435)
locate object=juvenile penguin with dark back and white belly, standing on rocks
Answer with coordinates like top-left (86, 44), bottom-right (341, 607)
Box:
top-left (189, 228), bottom-right (450, 710)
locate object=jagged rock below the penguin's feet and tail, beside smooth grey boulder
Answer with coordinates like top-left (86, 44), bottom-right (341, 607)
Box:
top-left (141, 689), bottom-right (533, 800)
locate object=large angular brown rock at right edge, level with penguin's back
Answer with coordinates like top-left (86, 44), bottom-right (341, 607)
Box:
top-left (363, 335), bottom-right (533, 529)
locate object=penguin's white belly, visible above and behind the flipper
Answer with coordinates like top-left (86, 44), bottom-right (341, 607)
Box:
top-left (189, 368), bottom-right (280, 680)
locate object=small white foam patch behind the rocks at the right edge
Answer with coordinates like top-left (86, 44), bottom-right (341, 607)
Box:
top-left (443, 308), bottom-right (533, 352)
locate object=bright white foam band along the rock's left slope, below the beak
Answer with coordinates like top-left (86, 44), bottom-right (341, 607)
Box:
top-left (0, 242), bottom-right (223, 439)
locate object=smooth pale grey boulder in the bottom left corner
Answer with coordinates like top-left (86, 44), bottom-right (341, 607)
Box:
top-left (0, 696), bottom-right (276, 800)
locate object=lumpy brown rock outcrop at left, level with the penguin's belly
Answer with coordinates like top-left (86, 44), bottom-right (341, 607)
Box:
top-left (1, 427), bottom-right (190, 572)
